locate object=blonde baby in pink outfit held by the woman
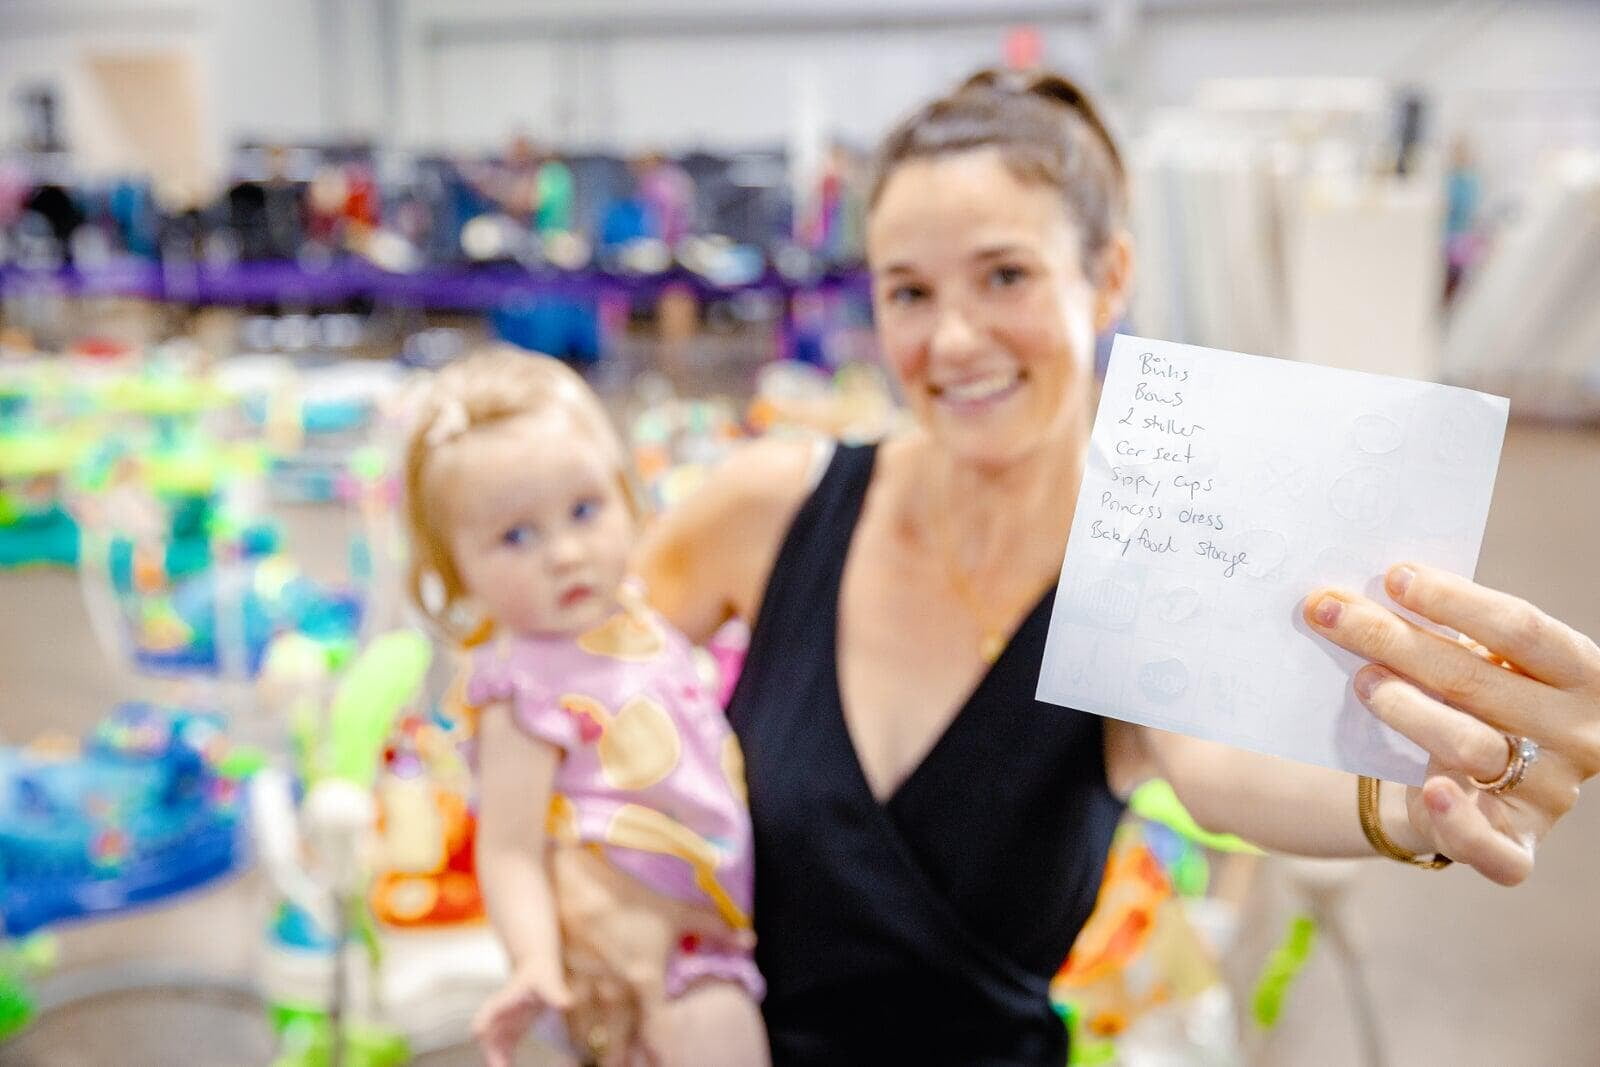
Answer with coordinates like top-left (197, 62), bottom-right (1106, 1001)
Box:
top-left (406, 349), bottom-right (768, 1067)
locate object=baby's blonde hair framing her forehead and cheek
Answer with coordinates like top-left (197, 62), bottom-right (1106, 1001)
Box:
top-left (405, 346), bottom-right (640, 643)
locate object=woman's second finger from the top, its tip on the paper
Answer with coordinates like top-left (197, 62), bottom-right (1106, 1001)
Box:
top-left (1306, 589), bottom-right (1565, 737)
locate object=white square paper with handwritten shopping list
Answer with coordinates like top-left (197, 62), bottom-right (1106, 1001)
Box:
top-left (1038, 336), bottom-right (1507, 784)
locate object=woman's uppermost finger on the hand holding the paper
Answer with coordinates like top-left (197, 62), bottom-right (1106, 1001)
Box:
top-left (1384, 563), bottom-right (1600, 688)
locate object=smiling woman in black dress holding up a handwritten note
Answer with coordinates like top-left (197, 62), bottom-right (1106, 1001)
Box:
top-left (553, 74), bottom-right (1600, 1064)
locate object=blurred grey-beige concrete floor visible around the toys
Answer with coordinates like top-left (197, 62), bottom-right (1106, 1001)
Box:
top-left (0, 426), bottom-right (1600, 1067)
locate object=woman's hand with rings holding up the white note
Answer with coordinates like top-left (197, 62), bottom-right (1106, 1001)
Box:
top-left (1306, 565), bottom-right (1600, 885)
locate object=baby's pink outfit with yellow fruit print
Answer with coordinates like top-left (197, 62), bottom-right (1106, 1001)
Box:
top-left (466, 605), bottom-right (762, 998)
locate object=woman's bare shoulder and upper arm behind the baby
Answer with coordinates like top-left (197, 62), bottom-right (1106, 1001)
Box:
top-left (634, 440), bottom-right (816, 643)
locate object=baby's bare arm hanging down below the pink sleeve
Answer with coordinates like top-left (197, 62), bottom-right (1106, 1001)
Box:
top-left (477, 704), bottom-right (565, 992)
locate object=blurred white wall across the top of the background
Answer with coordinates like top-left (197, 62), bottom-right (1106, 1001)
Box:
top-left (0, 0), bottom-right (1600, 168)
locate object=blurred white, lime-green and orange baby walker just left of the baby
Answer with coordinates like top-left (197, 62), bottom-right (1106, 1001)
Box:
top-left (253, 632), bottom-right (506, 1067)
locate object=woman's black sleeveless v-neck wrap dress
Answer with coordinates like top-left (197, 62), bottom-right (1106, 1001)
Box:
top-left (728, 446), bottom-right (1123, 1067)
